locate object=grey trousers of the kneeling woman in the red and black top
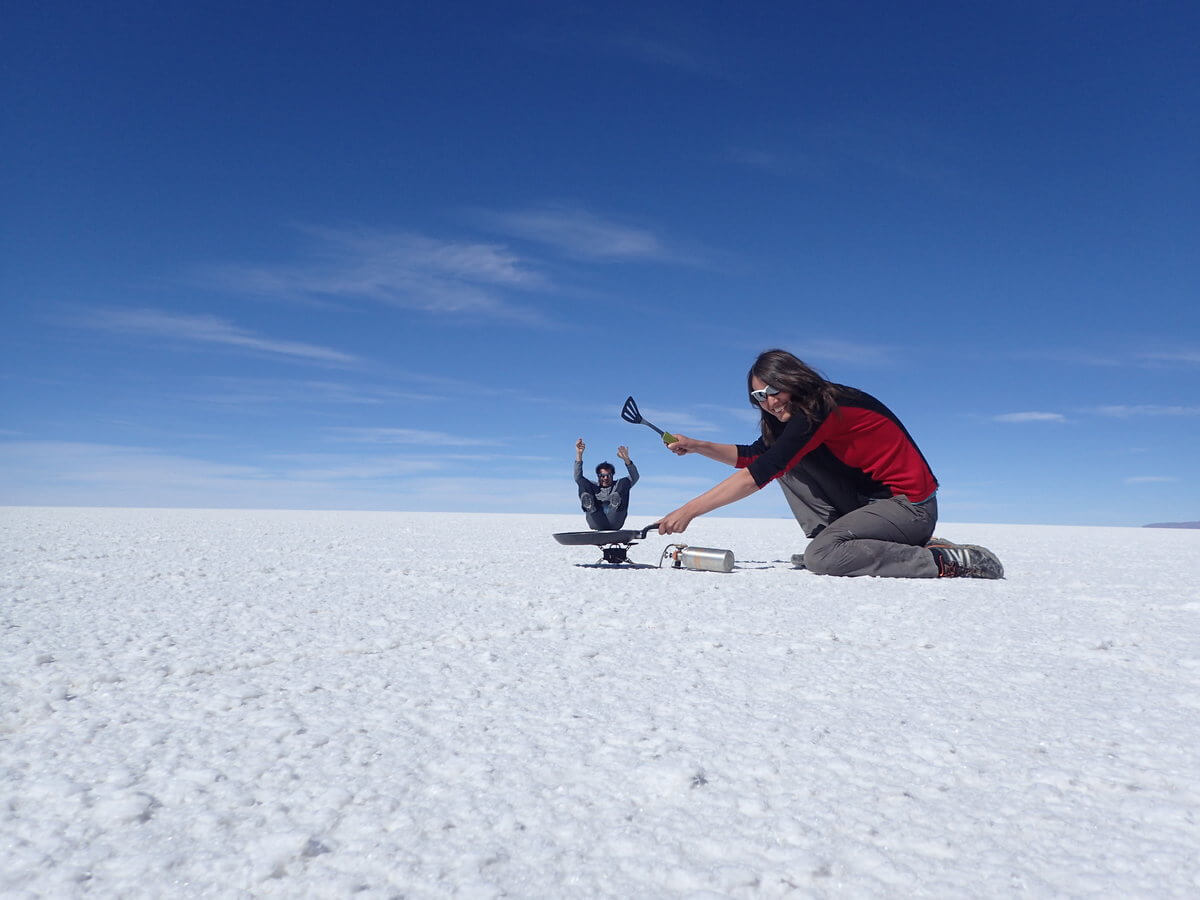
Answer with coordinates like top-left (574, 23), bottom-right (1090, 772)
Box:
top-left (779, 461), bottom-right (937, 578)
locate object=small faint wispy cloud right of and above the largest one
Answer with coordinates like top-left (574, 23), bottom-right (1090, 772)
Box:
top-left (476, 206), bottom-right (685, 262)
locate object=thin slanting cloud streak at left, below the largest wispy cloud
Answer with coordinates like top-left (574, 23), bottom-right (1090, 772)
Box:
top-left (74, 308), bottom-right (359, 366)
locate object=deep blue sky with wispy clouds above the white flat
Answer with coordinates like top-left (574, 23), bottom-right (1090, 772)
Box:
top-left (0, 0), bottom-right (1200, 528)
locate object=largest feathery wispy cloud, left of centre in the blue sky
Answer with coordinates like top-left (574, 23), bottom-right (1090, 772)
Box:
top-left (210, 228), bottom-right (550, 324)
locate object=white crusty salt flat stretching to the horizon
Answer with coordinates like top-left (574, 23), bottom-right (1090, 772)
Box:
top-left (0, 508), bottom-right (1200, 898)
